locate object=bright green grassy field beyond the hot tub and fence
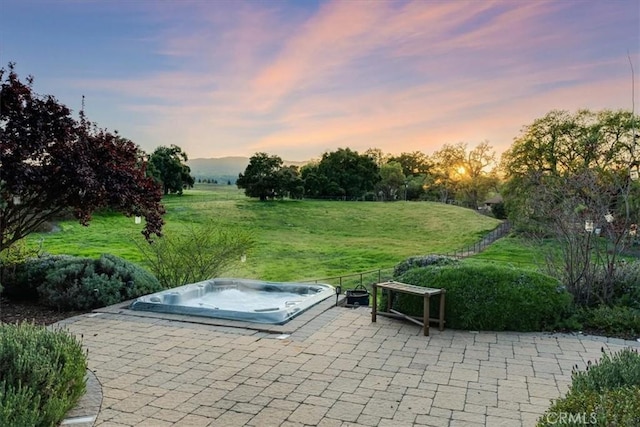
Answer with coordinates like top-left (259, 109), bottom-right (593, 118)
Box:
top-left (28, 184), bottom-right (499, 281)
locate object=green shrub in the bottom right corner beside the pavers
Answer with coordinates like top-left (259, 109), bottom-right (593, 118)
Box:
top-left (538, 348), bottom-right (640, 427)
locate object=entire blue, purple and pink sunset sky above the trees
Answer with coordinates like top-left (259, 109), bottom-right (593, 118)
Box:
top-left (0, 0), bottom-right (640, 161)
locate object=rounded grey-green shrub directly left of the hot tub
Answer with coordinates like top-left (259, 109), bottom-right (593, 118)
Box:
top-left (38, 254), bottom-right (162, 310)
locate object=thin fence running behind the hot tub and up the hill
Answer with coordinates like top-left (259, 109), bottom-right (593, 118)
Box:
top-left (303, 221), bottom-right (511, 289)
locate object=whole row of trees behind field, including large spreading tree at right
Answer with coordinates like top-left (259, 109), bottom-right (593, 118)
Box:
top-left (237, 110), bottom-right (640, 230)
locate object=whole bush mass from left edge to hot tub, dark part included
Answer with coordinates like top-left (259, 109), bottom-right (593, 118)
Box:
top-left (5, 254), bottom-right (163, 310)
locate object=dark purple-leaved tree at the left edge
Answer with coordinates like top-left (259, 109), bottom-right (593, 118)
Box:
top-left (0, 63), bottom-right (165, 252)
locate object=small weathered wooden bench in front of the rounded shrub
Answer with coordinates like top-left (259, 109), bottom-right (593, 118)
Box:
top-left (371, 282), bottom-right (446, 336)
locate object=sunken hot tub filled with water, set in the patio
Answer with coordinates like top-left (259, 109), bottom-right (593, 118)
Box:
top-left (129, 278), bottom-right (335, 324)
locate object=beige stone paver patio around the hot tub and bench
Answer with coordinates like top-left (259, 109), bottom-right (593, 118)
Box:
top-left (61, 307), bottom-right (640, 427)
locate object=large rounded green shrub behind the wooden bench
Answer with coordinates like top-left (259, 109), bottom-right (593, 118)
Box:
top-left (392, 265), bottom-right (571, 331)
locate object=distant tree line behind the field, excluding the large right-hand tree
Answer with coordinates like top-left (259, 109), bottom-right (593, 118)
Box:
top-left (236, 141), bottom-right (500, 209)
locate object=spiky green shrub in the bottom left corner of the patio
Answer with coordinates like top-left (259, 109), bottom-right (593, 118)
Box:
top-left (0, 323), bottom-right (87, 426)
